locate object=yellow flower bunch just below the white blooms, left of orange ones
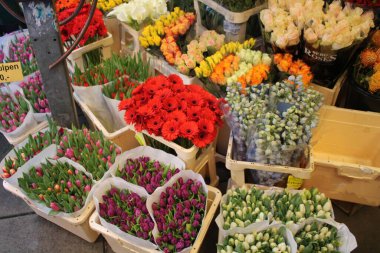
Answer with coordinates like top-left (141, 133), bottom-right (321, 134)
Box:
top-left (139, 7), bottom-right (185, 48)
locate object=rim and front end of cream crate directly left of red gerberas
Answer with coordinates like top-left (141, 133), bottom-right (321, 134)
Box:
top-left (74, 93), bottom-right (139, 151)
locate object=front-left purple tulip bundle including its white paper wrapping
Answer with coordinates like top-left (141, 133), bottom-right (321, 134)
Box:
top-left (93, 178), bottom-right (157, 249)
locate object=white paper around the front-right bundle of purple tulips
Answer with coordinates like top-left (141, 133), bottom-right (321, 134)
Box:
top-left (146, 170), bottom-right (208, 253)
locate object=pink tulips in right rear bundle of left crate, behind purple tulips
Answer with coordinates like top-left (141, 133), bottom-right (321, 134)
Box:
top-left (57, 128), bottom-right (121, 180)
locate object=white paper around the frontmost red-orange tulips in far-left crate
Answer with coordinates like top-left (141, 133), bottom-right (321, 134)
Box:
top-left (8, 144), bottom-right (93, 217)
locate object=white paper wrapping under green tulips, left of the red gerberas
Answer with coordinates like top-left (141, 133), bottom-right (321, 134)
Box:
top-left (72, 85), bottom-right (117, 132)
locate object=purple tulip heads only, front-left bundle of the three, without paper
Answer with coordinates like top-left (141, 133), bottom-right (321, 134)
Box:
top-left (99, 187), bottom-right (154, 243)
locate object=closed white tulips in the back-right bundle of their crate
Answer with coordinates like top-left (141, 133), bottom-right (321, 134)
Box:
top-left (271, 188), bottom-right (333, 225)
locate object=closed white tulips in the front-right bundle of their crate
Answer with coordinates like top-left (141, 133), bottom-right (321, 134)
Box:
top-left (294, 221), bottom-right (340, 253)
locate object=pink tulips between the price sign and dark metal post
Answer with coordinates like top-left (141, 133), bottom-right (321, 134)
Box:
top-left (20, 71), bottom-right (51, 113)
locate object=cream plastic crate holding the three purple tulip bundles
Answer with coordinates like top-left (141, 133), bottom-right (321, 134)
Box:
top-left (90, 186), bottom-right (222, 253)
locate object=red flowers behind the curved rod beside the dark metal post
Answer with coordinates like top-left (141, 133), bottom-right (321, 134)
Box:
top-left (58, 4), bottom-right (107, 48)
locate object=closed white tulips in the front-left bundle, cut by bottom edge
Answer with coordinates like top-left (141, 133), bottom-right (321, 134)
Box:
top-left (217, 227), bottom-right (291, 253)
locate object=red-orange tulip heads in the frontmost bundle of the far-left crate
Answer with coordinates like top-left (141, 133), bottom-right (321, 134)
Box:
top-left (18, 161), bottom-right (93, 213)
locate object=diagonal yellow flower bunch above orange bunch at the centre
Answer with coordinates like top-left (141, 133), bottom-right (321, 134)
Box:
top-left (194, 38), bottom-right (255, 78)
